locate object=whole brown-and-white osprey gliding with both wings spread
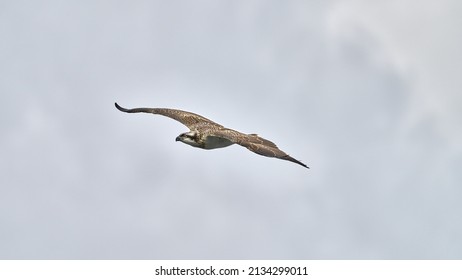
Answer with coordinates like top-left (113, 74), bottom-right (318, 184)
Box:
top-left (115, 103), bottom-right (309, 168)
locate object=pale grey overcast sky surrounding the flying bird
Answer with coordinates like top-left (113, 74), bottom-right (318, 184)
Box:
top-left (0, 0), bottom-right (462, 259)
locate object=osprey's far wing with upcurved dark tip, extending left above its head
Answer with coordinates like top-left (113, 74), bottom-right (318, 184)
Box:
top-left (115, 103), bottom-right (223, 130)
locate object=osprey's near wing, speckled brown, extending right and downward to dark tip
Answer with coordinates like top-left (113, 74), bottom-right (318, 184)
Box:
top-left (213, 129), bottom-right (309, 168)
